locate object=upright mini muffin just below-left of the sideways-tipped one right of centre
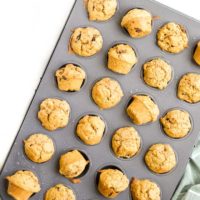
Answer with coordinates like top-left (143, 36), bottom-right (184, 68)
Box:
top-left (112, 127), bottom-right (141, 158)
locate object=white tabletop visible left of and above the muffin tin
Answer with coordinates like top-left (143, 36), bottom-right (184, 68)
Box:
top-left (0, 0), bottom-right (200, 168)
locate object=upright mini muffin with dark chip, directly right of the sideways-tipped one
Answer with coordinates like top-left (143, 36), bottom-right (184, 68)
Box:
top-left (160, 109), bottom-right (192, 138)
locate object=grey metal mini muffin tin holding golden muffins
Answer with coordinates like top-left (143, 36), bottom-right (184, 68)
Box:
top-left (0, 0), bottom-right (200, 200)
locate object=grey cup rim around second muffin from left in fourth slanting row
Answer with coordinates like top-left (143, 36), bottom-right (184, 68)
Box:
top-left (74, 112), bottom-right (108, 147)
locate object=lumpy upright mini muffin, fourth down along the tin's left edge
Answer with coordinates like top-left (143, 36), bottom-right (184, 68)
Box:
top-left (38, 99), bottom-right (70, 131)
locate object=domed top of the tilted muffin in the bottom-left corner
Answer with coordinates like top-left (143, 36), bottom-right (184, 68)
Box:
top-left (6, 171), bottom-right (40, 193)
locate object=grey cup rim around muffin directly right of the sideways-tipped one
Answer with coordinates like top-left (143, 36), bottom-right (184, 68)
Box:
top-left (160, 107), bottom-right (193, 142)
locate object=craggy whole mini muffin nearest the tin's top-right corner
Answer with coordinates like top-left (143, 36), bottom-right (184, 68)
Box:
top-left (157, 22), bottom-right (188, 53)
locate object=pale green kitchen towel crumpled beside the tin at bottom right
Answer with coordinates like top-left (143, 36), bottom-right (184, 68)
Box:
top-left (172, 139), bottom-right (200, 200)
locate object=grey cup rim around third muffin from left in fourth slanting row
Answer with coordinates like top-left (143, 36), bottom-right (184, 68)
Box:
top-left (110, 126), bottom-right (143, 162)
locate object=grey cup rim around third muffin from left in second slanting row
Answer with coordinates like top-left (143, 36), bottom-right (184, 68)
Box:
top-left (140, 55), bottom-right (174, 92)
